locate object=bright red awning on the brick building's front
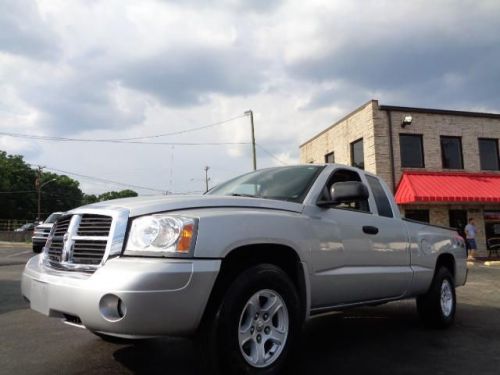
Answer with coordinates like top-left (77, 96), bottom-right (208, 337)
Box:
top-left (396, 172), bottom-right (500, 204)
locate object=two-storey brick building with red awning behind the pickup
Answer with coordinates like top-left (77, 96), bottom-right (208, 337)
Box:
top-left (300, 100), bottom-right (500, 255)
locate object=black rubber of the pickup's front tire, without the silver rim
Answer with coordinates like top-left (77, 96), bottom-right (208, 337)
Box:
top-left (215, 264), bottom-right (301, 375)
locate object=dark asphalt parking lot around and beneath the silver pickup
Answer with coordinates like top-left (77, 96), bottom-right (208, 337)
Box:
top-left (0, 247), bottom-right (500, 375)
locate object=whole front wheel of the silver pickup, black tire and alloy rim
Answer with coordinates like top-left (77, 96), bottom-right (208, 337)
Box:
top-left (199, 264), bottom-right (302, 375)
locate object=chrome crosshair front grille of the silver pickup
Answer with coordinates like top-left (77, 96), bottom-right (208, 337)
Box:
top-left (44, 209), bottom-right (128, 272)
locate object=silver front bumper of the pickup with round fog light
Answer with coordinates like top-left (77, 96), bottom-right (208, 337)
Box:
top-left (22, 256), bottom-right (221, 337)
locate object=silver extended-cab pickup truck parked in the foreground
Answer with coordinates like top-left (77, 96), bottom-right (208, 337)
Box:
top-left (22, 164), bottom-right (467, 374)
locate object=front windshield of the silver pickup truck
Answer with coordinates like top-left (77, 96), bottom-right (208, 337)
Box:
top-left (207, 165), bottom-right (324, 202)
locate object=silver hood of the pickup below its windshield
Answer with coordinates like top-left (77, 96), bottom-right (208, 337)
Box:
top-left (73, 195), bottom-right (304, 216)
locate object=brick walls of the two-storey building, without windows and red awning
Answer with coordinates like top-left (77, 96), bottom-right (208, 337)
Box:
top-left (300, 100), bottom-right (500, 255)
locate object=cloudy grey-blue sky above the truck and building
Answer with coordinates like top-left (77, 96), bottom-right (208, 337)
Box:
top-left (0, 0), bottom-right (500, 194)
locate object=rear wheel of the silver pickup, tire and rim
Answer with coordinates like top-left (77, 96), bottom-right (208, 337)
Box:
top-left (417, 267), bottom-right (457, 328)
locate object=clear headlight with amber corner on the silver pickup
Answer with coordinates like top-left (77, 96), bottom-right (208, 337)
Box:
top-left (125, 214), bottom-right (197, 256)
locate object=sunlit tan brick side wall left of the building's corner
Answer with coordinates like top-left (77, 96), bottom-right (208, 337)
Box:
top-left (300, 101), bottom-right (378, 173)
